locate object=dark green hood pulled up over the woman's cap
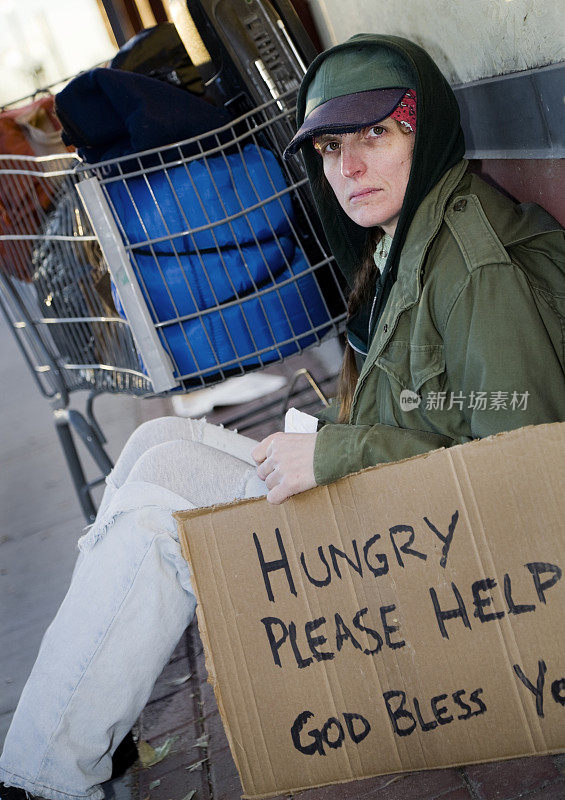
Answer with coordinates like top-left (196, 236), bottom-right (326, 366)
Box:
top-left (296, 33), bottom-right (465, 344)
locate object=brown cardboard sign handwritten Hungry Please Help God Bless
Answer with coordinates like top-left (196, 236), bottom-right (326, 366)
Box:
top-left (177, 423), bottom-right (565, 797)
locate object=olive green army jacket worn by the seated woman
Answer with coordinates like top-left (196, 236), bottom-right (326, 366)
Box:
top-left (314, 161), bottom-right (565, 484)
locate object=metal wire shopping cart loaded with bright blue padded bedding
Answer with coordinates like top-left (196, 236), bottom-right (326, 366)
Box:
top-left (0, 2), bottom-right (345, 521)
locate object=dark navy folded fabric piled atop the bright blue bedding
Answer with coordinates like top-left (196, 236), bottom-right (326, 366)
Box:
top-left (55, 69), bottom-right (231, 164)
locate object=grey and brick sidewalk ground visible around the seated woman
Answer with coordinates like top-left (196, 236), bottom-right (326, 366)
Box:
top-left (0, 312), bottom-right (565, 800)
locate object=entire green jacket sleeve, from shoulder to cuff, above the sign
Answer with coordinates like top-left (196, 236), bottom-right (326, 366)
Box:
top-left (314, 264), bottom-right (565, 484)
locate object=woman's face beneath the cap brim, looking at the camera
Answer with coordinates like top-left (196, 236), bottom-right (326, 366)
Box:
top-left (314, 117), bottom-right (414, 236)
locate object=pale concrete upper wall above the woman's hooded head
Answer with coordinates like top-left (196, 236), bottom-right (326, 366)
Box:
top-left (309, 0), bottom-right (565, 83)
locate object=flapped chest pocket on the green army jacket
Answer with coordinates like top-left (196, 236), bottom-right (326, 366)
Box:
top-left (375, 342), bottom-right (445, 392)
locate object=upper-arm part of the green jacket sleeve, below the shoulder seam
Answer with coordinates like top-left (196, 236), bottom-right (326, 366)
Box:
top-left (444, 264), bottom-right (565, 438)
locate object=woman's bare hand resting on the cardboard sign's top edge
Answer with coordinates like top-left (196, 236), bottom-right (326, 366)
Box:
top-left (251, 433), bottom-right (318, 504)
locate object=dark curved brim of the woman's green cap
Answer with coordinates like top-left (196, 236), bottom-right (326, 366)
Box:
top-left (283, 88), bottom-right (408, 159)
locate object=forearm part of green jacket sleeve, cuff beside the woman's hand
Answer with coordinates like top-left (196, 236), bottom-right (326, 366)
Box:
top-left (314, 424), bottom-right (455, 486)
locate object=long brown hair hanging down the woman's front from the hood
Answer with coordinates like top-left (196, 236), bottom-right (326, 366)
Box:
top-left (337, 228), bottom-right (383, 422)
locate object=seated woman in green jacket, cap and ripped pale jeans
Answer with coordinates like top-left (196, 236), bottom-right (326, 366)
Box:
top-left (0, 35), bottom-right (565, 800)
